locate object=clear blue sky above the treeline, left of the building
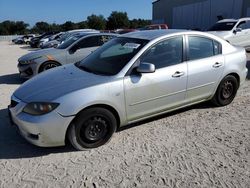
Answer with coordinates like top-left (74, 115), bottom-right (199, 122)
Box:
top-left (0, 0), bottom-right (152, 26)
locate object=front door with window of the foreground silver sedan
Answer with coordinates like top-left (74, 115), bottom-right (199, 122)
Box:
top-left (124, 36), bottom-right (187, 121)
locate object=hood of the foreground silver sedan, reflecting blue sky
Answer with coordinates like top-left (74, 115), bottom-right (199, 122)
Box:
top-left (14, 64), bottom-right (111, 103)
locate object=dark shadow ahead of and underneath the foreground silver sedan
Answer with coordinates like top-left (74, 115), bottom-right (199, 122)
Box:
top-left (0, 103), bottom-right (211, 160)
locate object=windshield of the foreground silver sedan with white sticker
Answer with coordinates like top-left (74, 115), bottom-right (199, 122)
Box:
top-left (75, 37), bottom-right (149, 75)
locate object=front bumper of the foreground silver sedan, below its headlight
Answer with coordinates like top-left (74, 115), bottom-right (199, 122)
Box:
top-left (9, 96), bottom-right (74, 147)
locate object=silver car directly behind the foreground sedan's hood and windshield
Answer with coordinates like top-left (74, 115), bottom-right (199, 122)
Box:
top-left (18, 33), bottom-right (117, 79)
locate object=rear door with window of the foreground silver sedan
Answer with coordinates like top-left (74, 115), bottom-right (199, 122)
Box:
top-left (187, 36), bottom-right (224, 102)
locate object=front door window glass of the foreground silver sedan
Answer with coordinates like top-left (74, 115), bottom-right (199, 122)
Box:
top-left (140, 36), bottom-right (183, 69)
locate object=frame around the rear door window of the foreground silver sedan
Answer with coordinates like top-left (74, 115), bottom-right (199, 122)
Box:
top-left (186, 34), bottom-right (222, 61)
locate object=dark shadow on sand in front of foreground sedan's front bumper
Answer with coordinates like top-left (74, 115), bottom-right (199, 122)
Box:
top-left (0, 109), bottom-right (75, 160)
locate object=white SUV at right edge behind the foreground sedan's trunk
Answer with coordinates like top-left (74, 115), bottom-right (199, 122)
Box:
top-left (208, 18), bottom-right (250, 47)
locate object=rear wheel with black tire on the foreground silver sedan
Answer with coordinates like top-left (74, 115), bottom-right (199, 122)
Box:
top-left (211, 75), bottom-right (239, 106)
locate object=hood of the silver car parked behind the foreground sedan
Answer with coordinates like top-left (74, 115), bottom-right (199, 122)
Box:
top-left (18, 48), bottom-right (63, 62)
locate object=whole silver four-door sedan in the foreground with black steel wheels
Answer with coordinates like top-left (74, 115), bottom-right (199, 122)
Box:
top-left (9, 30), bottom-right (248, 150)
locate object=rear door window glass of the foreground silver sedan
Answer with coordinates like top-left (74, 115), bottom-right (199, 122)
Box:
top-left (188, 36), bottom-right (221, 60)
